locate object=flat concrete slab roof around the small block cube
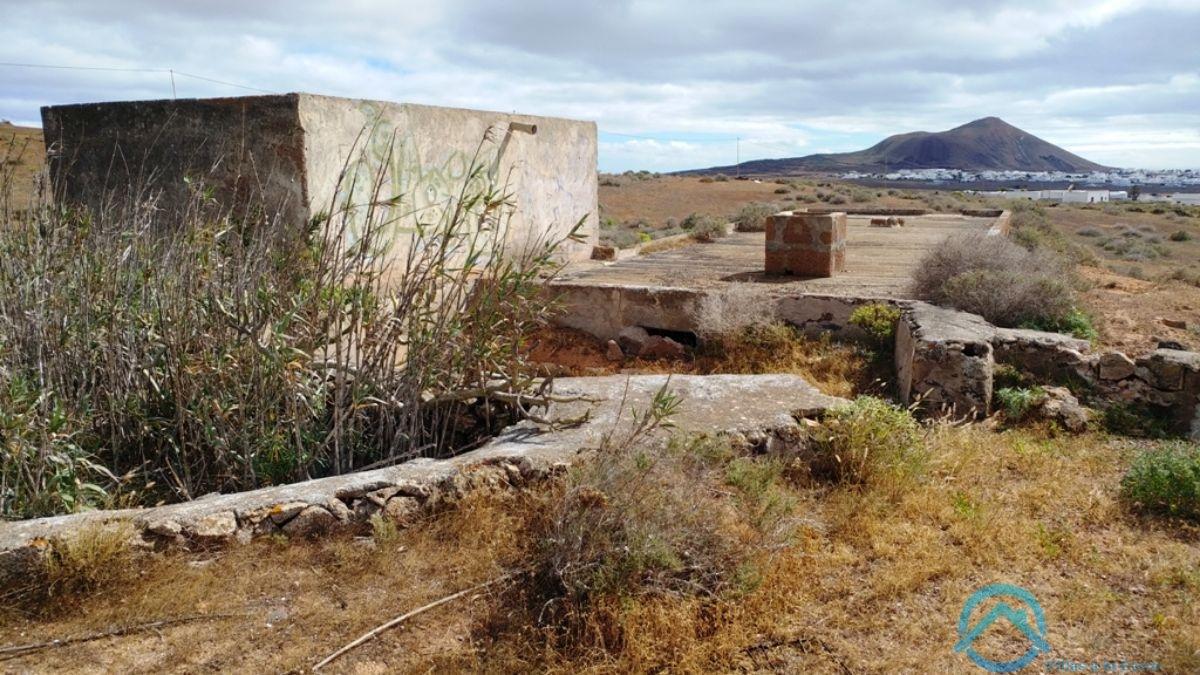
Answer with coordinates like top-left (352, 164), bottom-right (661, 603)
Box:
top-left (551, 215), bottom-right (996, 340)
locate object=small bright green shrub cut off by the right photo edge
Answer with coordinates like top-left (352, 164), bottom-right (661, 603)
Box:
top-left (1121, 442), bottom-right (1200, 520)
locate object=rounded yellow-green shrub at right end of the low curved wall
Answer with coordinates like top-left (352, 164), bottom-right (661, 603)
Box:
top-left (812, 396), bottom-right (929, 486)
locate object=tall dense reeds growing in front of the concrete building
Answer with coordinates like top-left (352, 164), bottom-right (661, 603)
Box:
top-left (0, 126), bottom-right (578, 516)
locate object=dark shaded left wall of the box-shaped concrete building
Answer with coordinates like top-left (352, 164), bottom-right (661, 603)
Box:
top-left (42, 94), bottom-right (308, 222)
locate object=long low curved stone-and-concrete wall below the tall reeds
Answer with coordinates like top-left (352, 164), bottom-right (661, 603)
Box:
top-left (0, 375), bottom-right (846, 576)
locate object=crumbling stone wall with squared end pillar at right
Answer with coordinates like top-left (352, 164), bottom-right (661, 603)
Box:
top-left (895, 303), bottom-right (1200, 440)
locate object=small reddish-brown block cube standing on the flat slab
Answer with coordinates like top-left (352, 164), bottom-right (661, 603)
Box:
top-left (767, 213), bottom-right (846, 277)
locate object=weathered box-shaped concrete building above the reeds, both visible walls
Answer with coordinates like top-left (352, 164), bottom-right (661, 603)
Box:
top-left (42, 94), bottom-right (599, 259)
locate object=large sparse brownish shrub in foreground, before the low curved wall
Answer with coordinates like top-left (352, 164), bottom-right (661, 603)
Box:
top-left (529, 420), bottom-right (794, 650)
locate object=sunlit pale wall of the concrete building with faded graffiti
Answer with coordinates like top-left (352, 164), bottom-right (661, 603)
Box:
top-left (299, 95), bottom-right (599, 259)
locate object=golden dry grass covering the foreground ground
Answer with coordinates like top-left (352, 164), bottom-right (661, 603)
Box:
top-left (0, 426), bottom-right (1200, 673)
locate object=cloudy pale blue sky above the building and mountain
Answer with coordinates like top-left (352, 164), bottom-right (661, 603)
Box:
top-left (0, 0), bottom-right (1200, 171)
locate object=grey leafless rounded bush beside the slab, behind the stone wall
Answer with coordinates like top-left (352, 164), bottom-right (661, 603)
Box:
top-left (912, 228), bottom-right (1076, 327)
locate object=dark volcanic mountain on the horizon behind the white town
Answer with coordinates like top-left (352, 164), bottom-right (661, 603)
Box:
top-left (682, 118), bottom-right (1109, 174)
